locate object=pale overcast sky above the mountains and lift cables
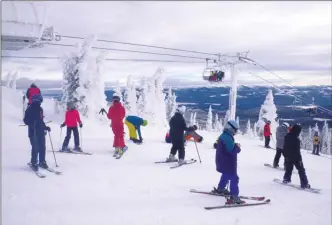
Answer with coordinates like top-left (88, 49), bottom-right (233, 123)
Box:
top-left (2, 1), bottom-right (332, 85)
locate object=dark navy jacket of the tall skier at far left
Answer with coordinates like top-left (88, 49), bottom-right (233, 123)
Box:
top-left (23, 103), bottom-right (46, 137)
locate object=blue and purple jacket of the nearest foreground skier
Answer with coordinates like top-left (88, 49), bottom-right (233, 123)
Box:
top-left (216, 130), bottom-right (241, 174)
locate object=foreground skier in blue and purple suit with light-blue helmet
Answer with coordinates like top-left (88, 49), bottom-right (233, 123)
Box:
top-left (212, 120), bottom-right (245, 204)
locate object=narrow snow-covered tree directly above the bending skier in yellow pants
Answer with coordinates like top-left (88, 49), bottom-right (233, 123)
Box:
top-left (124, 76), bottom-right (137, 115)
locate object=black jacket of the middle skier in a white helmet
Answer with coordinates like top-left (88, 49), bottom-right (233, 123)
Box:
top-left (169, 112), bottom-right (193, 142)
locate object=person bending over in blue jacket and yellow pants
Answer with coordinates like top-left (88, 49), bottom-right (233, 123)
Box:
top-left (125, 116), bottom-right (148, 143)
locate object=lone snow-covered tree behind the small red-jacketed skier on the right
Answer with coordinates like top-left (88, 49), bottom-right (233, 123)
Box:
top-left (257, 90), bottom-right (278, 137)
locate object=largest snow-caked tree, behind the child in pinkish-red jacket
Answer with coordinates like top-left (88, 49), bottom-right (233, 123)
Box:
top-left (61, 36), bottom-right (95, 116)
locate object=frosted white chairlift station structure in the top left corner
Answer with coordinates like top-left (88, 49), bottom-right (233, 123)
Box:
top-left (1, 1), bottom-right (61, 51)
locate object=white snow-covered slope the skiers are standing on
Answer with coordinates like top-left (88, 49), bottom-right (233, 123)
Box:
top-left (1, 87), bottom-right (331, 225)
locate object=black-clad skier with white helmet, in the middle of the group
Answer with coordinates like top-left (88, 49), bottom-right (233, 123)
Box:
top-left (166, 106), bottom-right (194, 164)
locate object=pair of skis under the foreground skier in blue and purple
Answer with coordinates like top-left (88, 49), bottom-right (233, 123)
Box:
top-left (190, 189), bottom-right (271, 210)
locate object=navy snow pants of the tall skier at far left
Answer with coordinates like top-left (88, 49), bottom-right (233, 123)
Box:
top-left (29, 134), bottom-right (46, 164)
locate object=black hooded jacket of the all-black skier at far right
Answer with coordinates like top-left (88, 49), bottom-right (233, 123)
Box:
top-left (283, 125), bottom-right (302, 162)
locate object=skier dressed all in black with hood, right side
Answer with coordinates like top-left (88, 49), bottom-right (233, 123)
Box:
top-left (283, 124), bottom-right (310, 188)
